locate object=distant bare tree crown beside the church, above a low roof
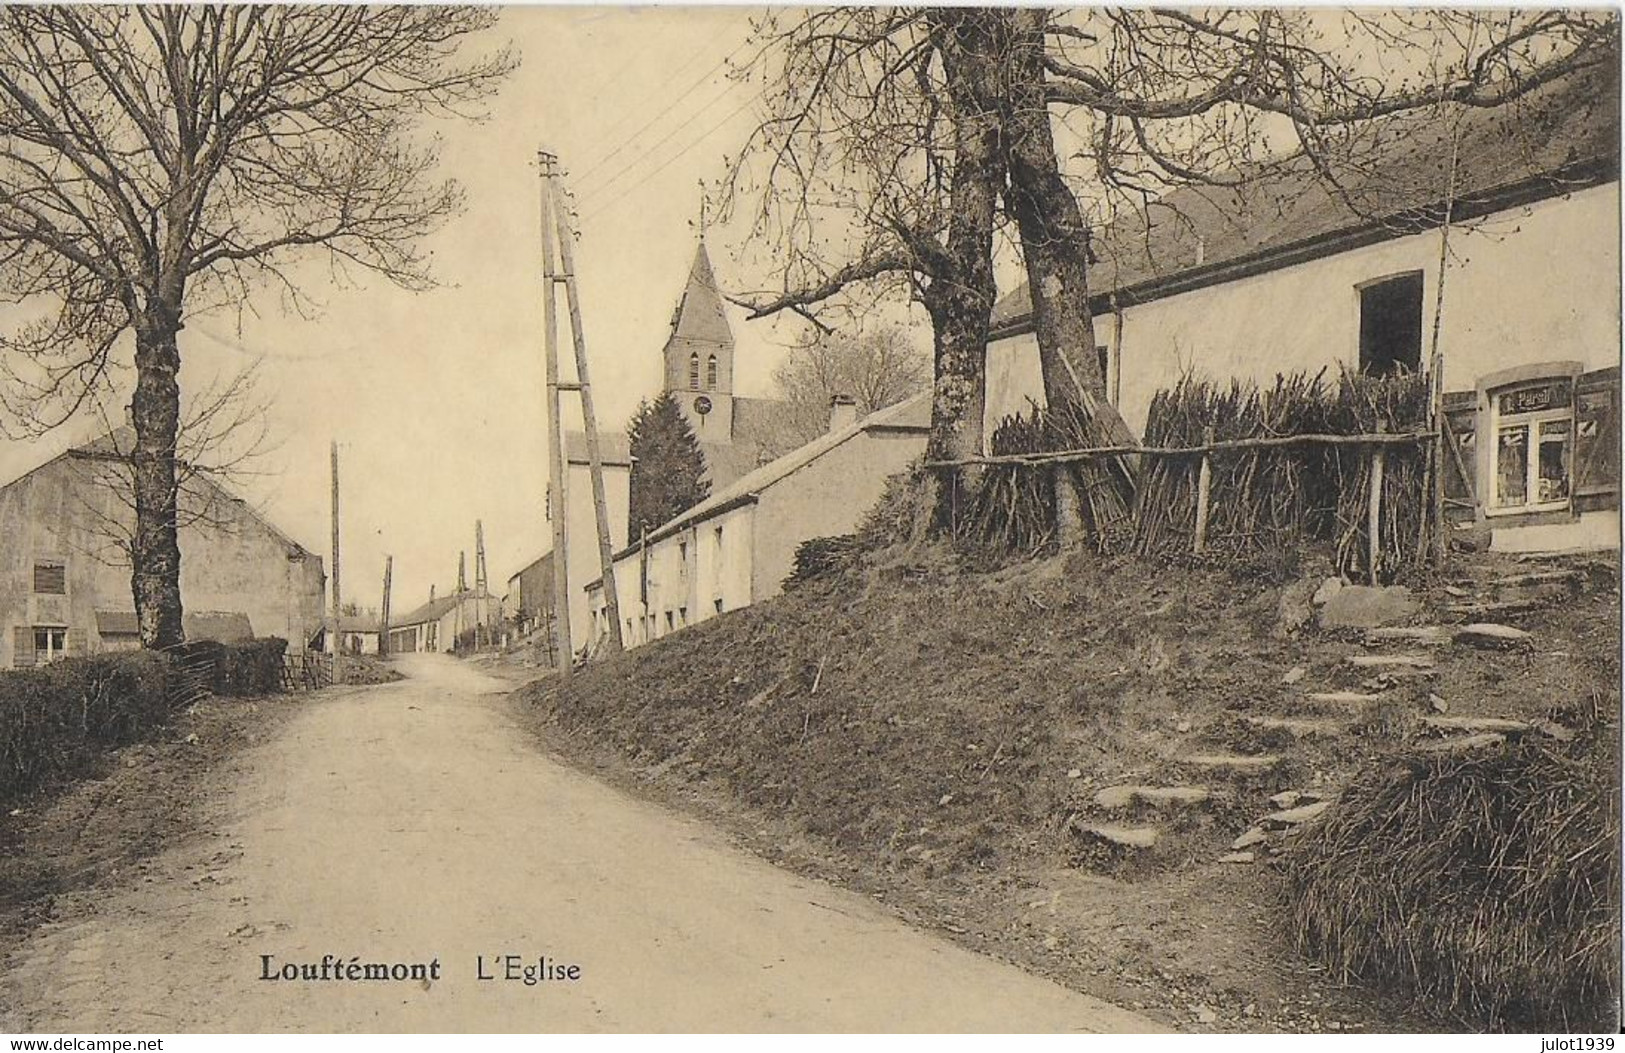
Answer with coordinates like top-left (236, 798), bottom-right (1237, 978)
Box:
top-left (772, 325), bottom-right (931, 457)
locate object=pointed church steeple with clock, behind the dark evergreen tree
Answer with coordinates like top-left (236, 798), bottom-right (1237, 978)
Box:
top-left (663, 232), bottom-right (733, 442)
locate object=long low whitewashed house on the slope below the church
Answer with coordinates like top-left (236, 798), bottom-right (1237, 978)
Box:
top-left (587, 392), bottom-right (931, 647)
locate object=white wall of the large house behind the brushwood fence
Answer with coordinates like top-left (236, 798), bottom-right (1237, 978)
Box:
top-left (983, 179), bottom-right (1620, 549)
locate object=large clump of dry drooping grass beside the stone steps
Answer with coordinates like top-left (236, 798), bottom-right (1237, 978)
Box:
top-left (1287, 728), bottom-right (1620, 1030)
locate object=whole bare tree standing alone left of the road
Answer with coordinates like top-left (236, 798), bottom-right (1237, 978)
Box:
top-left (0, 5), bottom-right (514, 647)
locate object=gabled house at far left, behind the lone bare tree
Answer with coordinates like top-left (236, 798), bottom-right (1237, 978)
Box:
top-left (0, 431), bottom-right (327, 666)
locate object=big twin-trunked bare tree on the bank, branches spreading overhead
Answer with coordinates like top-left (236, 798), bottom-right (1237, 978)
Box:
top-left (735, 8), bottom-right (1619, 484)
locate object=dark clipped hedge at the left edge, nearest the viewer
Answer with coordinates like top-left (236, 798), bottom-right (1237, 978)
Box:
top-left (0, 652), bottom-right (172, 801)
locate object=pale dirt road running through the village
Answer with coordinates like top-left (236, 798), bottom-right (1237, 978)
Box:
top-left (0, 658), bottom-right (1155, 1032)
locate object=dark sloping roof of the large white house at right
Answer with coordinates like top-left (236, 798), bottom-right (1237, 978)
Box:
top-left (993, 63), bottom-right (1620, 328)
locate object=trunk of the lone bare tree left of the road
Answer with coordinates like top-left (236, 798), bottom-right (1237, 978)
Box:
top-left (130, 297), bottom-right (185, 648)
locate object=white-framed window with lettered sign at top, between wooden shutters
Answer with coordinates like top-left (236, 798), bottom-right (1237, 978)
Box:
top-left (1487, 379), bottom-right (1575, 515)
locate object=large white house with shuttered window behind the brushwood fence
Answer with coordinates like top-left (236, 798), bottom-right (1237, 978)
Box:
top-left (985, 59), bottom-right (1620, 549)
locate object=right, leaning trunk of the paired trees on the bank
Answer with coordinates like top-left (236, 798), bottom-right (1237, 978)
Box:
top-left (1006, 8), bottom-right (1107, 406)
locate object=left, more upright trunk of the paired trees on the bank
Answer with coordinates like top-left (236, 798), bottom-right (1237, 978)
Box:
top-left (923, 8), bottom-right (1006, 527)
